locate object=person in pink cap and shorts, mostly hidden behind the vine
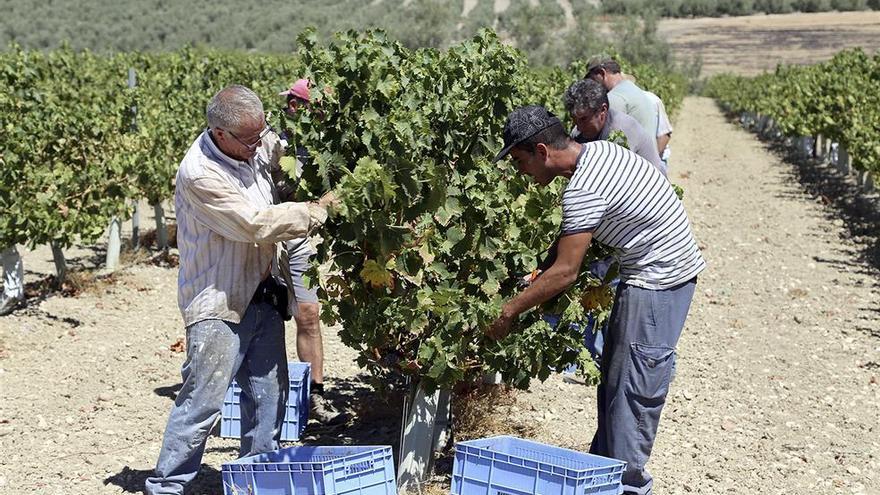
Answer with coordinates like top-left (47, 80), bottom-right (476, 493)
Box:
top-left (272, 79), bottom-right (346, 425)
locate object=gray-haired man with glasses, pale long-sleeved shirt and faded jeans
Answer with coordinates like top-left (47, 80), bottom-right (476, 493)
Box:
top-left (145, 85), bottom-right (335, 495)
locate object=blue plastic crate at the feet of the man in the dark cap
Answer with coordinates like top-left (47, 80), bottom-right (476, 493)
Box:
top-left (451, 436), bottom-right (626, 495)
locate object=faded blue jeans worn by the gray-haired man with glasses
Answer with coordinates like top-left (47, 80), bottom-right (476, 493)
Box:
top-left (145, 302), bottom-right (288, 495)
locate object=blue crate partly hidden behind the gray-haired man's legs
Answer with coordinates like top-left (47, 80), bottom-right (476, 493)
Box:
top-left (220, 362), bottom-right (311, 440)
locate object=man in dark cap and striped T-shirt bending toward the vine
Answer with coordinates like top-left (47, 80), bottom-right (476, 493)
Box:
top-left (487, 106), bottom-right (706, 495)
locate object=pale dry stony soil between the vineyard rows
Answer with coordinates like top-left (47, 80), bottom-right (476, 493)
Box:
top-left (0, 98), bottom-right (880, 495)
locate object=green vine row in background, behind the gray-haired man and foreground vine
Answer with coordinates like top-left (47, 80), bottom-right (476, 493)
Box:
top-left (0, 31), bottom-right (685, 258)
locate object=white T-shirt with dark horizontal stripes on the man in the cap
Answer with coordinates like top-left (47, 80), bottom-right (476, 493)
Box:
top-left (562, 141), bottom-right (706, 289)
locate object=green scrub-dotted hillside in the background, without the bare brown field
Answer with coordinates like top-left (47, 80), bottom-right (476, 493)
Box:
top-left (0, 0), bottom-right (671, 70)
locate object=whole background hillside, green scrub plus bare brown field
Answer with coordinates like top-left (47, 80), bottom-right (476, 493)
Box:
top-left (0, 0), bottom-right (880, 75)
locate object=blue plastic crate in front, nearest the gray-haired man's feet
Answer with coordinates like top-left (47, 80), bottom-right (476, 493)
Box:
top-left (222, 445), bottom-right (397, 495)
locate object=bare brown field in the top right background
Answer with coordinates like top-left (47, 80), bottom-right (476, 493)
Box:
top-left (658, 11), bottom-right (880, 76)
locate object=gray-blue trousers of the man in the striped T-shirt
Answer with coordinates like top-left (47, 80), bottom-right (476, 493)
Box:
top-left (590, 278), bottom-right (697, 495)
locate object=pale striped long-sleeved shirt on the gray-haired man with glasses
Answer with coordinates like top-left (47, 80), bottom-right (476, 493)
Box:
top-left (174, 131), bottom-right (327, 326)
